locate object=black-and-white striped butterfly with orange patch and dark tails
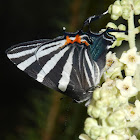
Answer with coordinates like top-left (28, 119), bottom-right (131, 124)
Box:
top-left (6, 13), bottom-right (121, 103)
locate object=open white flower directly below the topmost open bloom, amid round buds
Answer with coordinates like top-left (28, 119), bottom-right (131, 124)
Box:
top-left (116, 76), bottom-right (138, 98)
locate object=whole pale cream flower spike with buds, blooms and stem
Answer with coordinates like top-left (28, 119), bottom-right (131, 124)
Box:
top-left (79, 0), bottom-right (140, 140)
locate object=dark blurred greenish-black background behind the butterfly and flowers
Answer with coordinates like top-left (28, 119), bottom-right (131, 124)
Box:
top-left (0, 0), bottom-right (139, 140)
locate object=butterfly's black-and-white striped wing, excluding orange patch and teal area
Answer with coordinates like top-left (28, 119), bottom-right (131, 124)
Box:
top-left (7, 36), bottom-right (99, 102)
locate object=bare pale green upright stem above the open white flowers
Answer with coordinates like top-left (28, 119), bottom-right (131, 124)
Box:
top-left (128, 5), bottom-right (136, 48)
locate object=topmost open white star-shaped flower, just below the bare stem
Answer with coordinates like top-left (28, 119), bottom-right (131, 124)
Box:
top-left (120, 47), bottom-right (140, 71)
